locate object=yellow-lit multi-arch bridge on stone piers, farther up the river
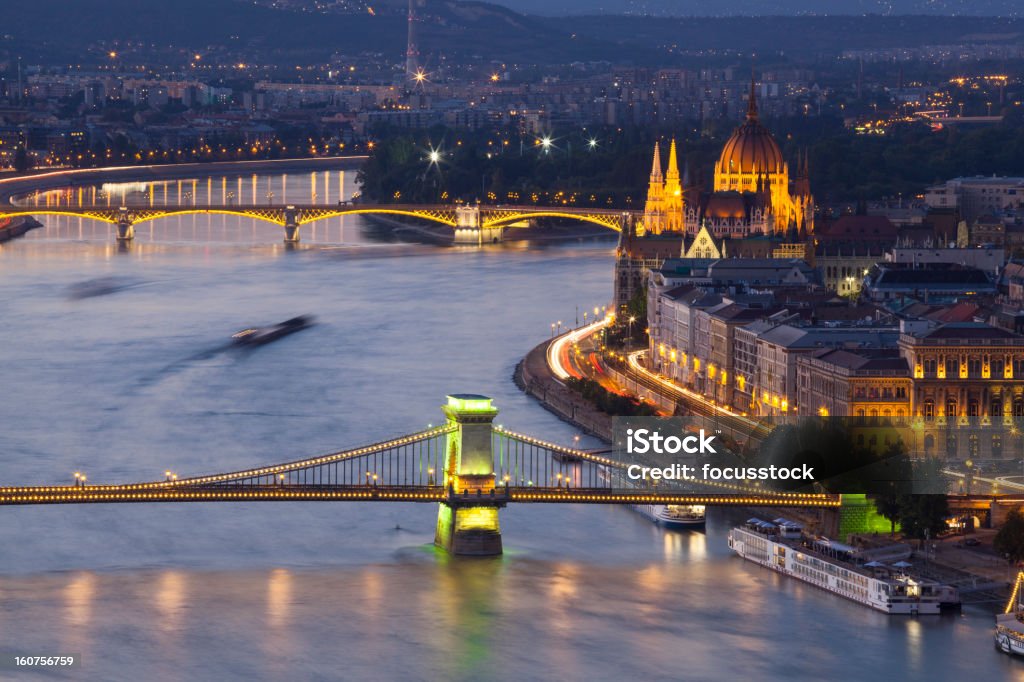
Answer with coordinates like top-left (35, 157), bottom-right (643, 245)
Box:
top-left (0, 204), bottom-right (638, 244)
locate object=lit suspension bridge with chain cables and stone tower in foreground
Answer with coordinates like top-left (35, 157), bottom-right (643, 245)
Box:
top-left (0, 394), bottom-right (841, 555)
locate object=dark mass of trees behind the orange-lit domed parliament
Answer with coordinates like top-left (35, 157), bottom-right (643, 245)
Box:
top-left (360, 116), bottom-right (1024, 209)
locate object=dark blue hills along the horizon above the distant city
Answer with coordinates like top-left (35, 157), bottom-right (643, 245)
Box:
top-left (0, 0), bottom-right (1024, 66)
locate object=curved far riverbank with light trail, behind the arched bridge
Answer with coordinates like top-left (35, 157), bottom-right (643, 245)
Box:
top-left (0, 156), bottom-right (367, 204)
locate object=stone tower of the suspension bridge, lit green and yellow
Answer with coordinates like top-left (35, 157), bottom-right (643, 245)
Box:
top-left (434, 393), bottom-right (507, 556)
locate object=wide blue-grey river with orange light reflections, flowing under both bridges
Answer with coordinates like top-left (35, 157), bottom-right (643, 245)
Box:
top-left (0, 174), bottom-right (1024, 680)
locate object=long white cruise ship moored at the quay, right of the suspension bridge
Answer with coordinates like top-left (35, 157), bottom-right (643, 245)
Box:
top-left (729, 518), bottom-right (959, 615)
